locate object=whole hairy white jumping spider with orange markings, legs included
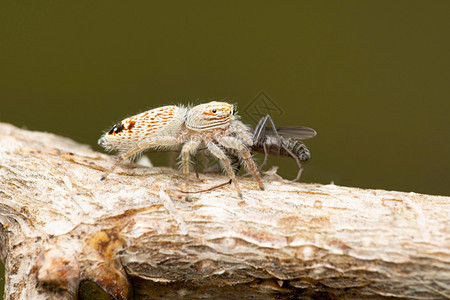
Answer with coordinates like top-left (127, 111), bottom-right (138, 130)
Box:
top-left (98, 101), bottom-right (264, 196)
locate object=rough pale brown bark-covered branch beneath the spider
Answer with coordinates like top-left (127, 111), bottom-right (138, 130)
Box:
top-left (0, 123), bottom-right (450, 299)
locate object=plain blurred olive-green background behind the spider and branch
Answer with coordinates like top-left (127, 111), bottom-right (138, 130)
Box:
top-left (0, 1), bottom-right (450, 296)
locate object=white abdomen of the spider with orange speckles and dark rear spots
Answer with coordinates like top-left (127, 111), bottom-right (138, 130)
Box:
top-left (99, 105), bottom-right (186, 150)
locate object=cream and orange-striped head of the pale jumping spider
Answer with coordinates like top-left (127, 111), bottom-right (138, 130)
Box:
top-left (186, 101), bottom-right (236, 131)
